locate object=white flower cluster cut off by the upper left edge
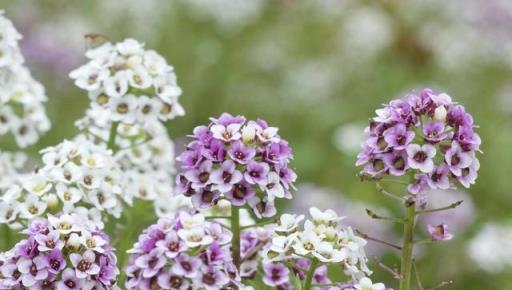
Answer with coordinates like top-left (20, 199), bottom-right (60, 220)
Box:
top-left (0, 10), bottom-right (50, 147)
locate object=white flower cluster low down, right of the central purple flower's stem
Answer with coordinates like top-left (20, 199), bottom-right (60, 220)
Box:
top-left (262, 207), bottom-right (372, 279)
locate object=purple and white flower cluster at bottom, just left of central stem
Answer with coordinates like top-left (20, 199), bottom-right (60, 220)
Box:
top-left (125, 211), bottom-right (240, 290)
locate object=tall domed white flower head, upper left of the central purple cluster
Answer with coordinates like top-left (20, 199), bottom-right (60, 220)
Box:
top-left (70, 39), bottom-right (184, 124)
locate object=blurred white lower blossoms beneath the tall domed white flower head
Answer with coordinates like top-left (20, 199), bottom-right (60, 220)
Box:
top-left (76, 106), bottom-right (181, 217)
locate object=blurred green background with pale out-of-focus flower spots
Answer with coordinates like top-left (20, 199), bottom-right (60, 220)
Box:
top-left (0, 0), bottom-right (512, 290)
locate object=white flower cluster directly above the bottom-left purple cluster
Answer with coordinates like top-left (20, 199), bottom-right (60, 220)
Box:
top-left (19, 137), bottom-right (127, 219)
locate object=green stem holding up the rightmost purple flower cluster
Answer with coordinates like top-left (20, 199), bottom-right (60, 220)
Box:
top-left (399, 201), bottom-right (416, 290)
